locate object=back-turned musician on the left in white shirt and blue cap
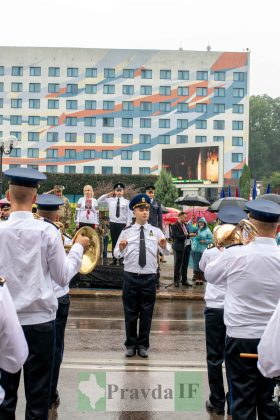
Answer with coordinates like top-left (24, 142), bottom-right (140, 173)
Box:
top-left (0, 168), bottom-right (89, 420)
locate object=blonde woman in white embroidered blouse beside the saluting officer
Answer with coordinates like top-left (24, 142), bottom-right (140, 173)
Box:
top-left (75, 185), bottom-right (99, 229)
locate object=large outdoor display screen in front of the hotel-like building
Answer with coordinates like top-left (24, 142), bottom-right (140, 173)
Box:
top-left (162, 146), bottom-right (219, 184)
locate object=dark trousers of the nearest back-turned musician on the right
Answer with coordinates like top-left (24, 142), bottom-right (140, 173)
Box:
top-left (226, 336), bottom-right (279, 420)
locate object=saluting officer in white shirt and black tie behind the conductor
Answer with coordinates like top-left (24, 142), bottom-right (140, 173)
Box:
top-left (97, 182), bottom-right (132, 265)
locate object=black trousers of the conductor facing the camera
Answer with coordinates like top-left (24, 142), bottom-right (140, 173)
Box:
top-left (122, 271), bottom-right (156, 349)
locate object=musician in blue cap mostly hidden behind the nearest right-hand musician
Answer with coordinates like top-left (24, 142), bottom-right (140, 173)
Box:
top-left (199, 206), bottom-right (248, 415)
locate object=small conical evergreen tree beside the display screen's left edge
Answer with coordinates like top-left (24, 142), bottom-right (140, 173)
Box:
top-left (155, 169), bottom-right (178, 207)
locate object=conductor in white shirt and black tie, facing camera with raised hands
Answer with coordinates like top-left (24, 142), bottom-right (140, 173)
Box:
top-left (114, 194), bottom-right (169, 357)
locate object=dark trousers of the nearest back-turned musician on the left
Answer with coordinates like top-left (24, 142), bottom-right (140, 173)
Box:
top-left (0, 321), bottom-right (55, 420)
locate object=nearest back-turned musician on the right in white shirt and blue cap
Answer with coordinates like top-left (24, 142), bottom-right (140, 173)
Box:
top-left (205, 199), bottom-right (280, 420)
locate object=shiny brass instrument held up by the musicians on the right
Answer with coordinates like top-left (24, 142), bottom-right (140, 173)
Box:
top-left (214, 219), bottom-right (258, 248)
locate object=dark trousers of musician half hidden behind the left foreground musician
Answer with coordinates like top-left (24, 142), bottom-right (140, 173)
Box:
top-left (49, 294), bottom-right (70, 406)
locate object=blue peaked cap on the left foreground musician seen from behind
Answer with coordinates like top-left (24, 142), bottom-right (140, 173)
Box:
top-left (4, 168), bottom-right (47, 188)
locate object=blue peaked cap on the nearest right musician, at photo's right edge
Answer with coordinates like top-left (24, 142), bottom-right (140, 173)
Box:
top-left (246, 199), bottom-right (280, 223)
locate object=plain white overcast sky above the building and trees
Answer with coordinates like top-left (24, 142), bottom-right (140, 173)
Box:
top-left (0, 0), bottom-right (280, 97)
